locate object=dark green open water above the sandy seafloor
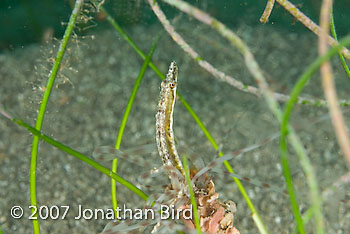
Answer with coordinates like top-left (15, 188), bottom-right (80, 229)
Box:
top-left (0, 0), bottom-right (350, 50)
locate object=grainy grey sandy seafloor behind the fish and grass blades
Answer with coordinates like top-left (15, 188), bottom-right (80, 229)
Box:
top-left (0, 18), bottom-right (350, 233)
